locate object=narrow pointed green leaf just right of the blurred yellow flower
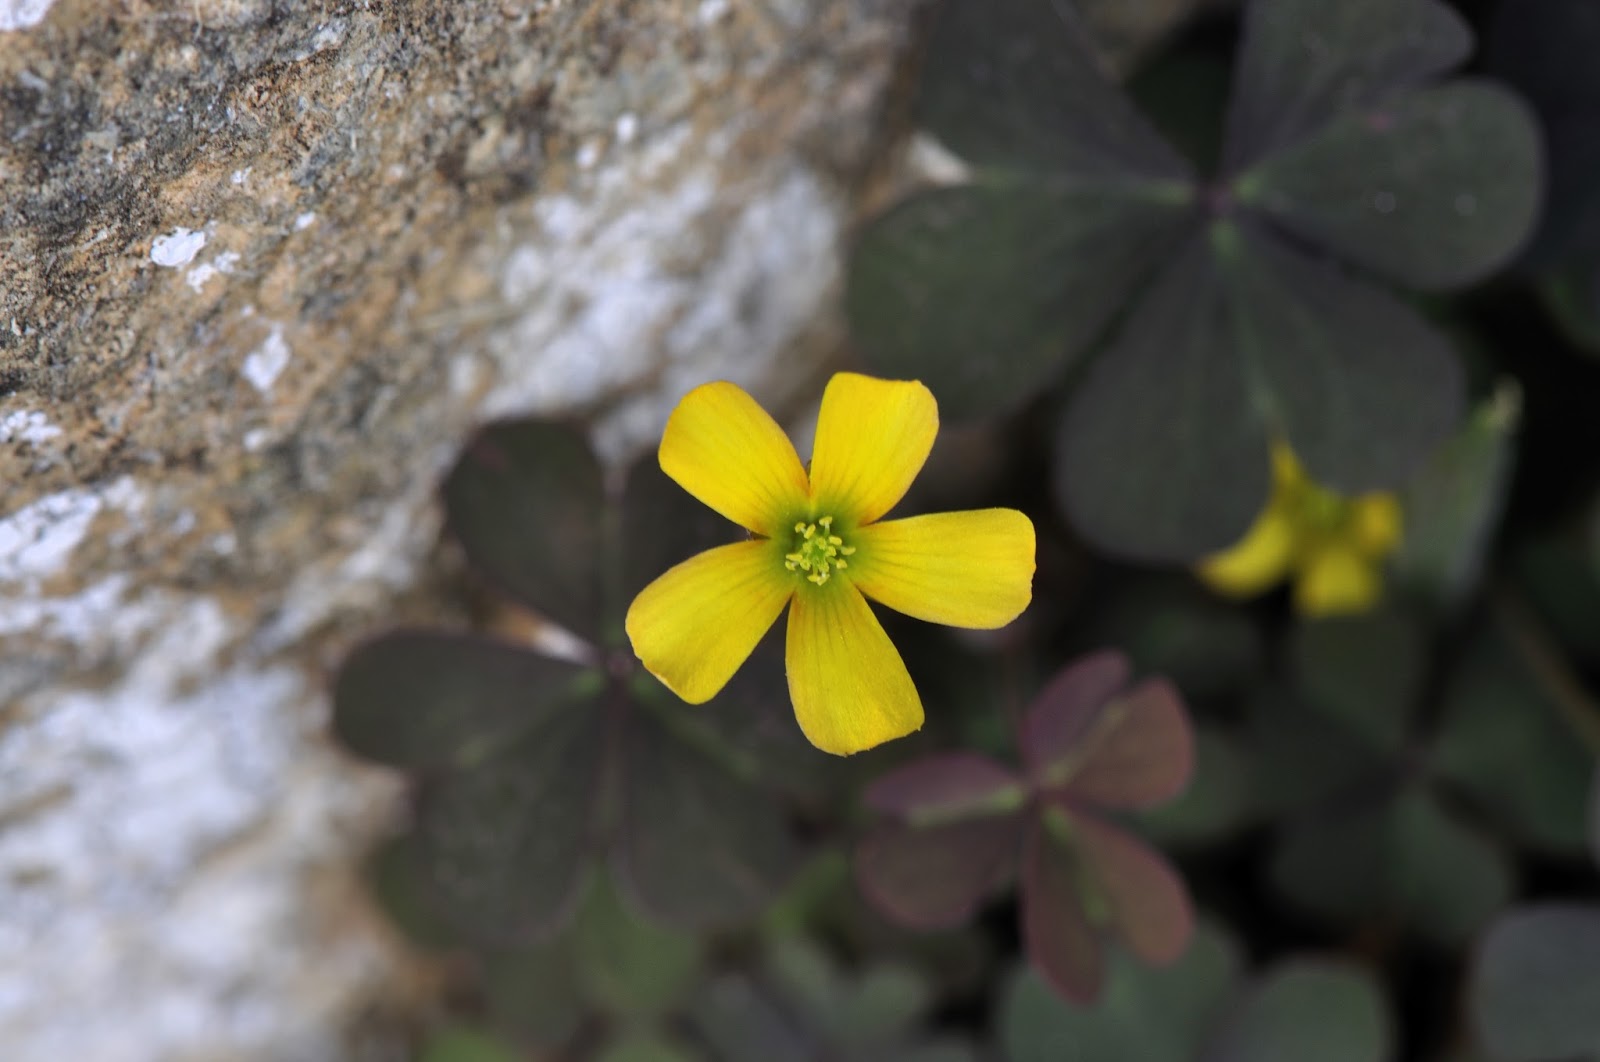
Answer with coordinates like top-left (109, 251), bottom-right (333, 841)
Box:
top-left (1392, 381), bottom-right (1522, 608)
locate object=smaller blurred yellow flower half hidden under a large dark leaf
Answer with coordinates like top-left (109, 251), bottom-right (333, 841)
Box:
top-left (1197, 443), bottom-right (1402, 617)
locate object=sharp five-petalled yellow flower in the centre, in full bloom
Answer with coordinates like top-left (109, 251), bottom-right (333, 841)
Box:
top-left (627, 373), bottom-right (1034, 755)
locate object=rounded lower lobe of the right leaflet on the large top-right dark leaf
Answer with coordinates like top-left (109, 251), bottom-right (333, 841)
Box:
top-left (1237, 82), bottom-right (1544, 288)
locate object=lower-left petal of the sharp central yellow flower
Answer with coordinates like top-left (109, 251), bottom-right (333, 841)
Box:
top-left (626, 541), bottom-right (794, 704)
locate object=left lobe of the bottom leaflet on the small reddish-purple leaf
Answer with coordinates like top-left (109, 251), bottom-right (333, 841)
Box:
top-left (1022, 817), bottom-right (1106, 1004)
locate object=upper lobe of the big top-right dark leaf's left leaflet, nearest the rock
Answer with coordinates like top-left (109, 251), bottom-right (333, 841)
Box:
top-left (918, 0), bottom-right (1189, 181)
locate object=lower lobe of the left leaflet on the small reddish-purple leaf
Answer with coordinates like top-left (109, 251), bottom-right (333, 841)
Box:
top-left (856, 814), bottom-right (1026, 929)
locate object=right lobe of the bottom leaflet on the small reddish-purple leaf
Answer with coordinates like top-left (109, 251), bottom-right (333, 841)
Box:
top-left (1045, 804), bottom-right (1195, 966)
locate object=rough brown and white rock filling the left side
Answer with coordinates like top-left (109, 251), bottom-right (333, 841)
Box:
top-left (0, 0), bottom-right (1203, 1062)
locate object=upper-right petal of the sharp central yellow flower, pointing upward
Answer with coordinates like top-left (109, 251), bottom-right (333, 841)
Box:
top-left (811, 373), bottom-right (939, 525)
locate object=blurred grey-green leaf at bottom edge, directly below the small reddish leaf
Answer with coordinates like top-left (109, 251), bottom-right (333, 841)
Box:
top-left (1000, 923), bottom-right (1394, 1062)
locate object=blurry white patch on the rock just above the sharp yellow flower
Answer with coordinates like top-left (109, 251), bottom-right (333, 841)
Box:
top-left (483, 121), bottom-right (848, 454)
